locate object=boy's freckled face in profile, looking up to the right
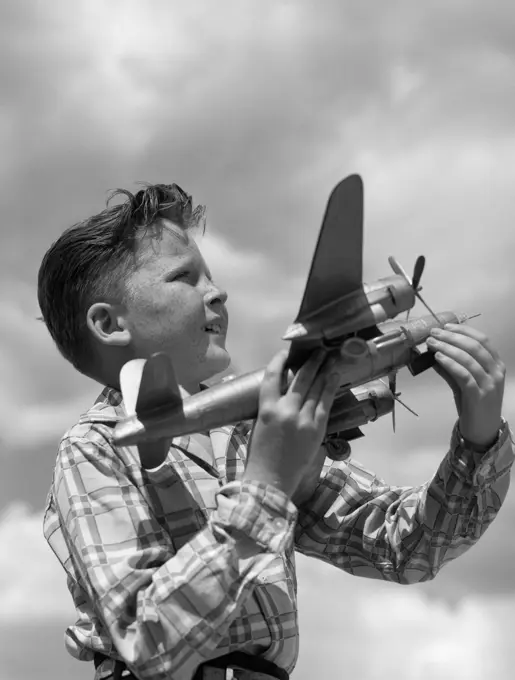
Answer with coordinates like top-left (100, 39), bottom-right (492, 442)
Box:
top-left (124, 222), bottom-right (230, 393)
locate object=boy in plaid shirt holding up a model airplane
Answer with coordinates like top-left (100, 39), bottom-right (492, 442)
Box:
top-left (38, 185), bottom-right (514, 680)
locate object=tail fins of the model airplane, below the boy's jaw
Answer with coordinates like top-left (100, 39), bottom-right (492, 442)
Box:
top-left (120, 353), bottom-right (182, 470)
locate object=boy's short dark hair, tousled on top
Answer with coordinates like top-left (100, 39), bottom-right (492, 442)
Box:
top-left (38, 184), bottom-right (205, 377)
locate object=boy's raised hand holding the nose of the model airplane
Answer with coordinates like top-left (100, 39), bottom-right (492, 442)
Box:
top-left (427, 324), bottom-right (506, 451)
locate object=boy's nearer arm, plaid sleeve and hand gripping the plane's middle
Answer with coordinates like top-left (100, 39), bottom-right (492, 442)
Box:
top-left (45, 352), bottom-right (339, 680)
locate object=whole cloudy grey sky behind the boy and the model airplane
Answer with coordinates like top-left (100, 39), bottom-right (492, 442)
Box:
top-left (0, 0), bottom-right (515, 680)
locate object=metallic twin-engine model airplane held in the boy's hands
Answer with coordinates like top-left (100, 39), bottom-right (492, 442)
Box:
top-left (114, 175), bottom-right (480, 467)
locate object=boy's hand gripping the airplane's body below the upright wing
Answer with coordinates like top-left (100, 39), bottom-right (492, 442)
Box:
top-left (243, 351), bottom-right (340, 499)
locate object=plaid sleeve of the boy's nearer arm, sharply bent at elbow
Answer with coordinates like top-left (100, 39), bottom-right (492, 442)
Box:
top-left (54, 438), bottom-right (297, 680)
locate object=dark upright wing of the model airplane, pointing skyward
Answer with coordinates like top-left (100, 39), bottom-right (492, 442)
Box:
top-left (295, 175), bottom-right (363, 322)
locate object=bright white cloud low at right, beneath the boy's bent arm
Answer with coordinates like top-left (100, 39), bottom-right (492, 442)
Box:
top-left (294, 557), bottom-right (515, 680)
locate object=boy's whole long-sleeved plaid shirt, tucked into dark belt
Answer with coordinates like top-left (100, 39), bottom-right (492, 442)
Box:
top-left (44, 388), bottom-right (514, 680)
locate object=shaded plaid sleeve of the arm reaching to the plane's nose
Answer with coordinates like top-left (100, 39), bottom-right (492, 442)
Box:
top-left (295, 422), bottom-right (514, 584)
